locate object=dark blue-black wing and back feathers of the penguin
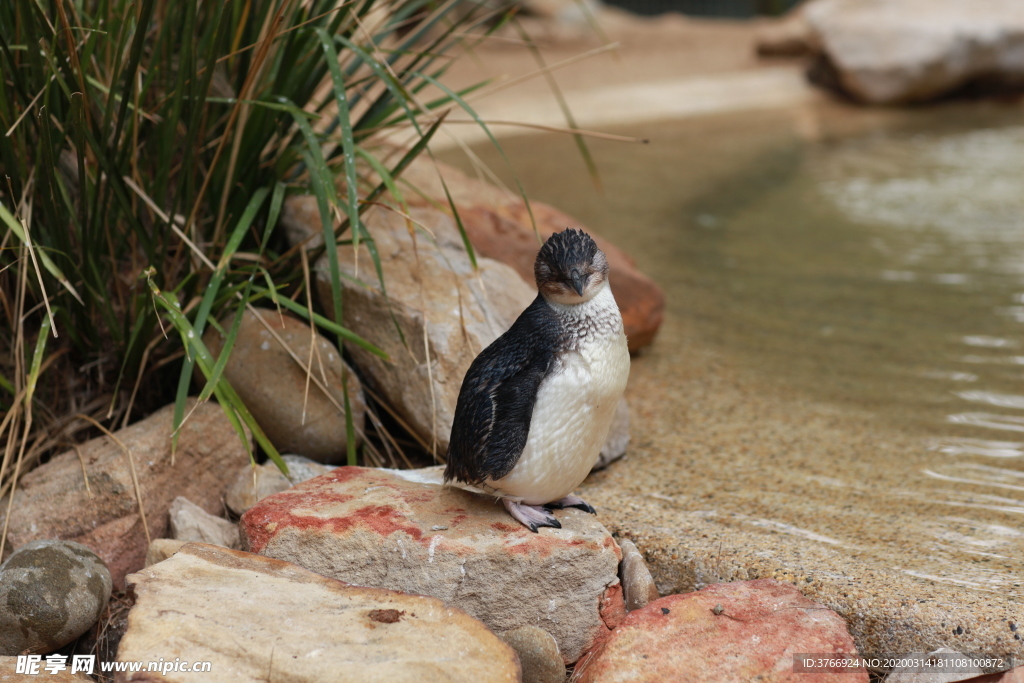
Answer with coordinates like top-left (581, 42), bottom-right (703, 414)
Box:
top-left (444, 295), bottom-right (561, 484)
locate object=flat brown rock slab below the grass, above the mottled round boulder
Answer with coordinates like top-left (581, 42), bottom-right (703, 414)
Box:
top-left (0, 402), bottom-right (249, 588)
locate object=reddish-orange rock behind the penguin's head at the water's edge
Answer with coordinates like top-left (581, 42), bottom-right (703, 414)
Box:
top-left (391, 151), bottom-right (665, 351)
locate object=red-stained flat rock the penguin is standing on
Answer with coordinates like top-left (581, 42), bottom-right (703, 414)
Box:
top-left (240, 467), bottom-right (625, 664)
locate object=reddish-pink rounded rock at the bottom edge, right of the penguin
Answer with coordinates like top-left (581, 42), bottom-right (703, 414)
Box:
top-left (573, 579), bottom-right (867, 683)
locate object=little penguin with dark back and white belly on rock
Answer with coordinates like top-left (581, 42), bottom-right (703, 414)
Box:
top-left (444, 228), bottom-right (630, 533)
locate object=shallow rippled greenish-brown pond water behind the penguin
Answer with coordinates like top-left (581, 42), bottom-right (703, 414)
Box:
top-left (436, 98), bottom-right (1024, 596)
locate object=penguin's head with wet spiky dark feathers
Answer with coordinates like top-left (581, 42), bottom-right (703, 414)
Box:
top-left (534, 227), bottom-right (608, 305)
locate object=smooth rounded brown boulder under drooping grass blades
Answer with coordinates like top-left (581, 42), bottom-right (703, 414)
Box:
top-left (197, 309), bottom-right (366, 463)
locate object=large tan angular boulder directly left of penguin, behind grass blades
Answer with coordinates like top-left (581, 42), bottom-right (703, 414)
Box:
top-left (282, 197), bottom-right (536, 454)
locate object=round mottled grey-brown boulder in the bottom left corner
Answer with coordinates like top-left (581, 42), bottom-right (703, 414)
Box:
top-left (0, 540), bottom-right (111, 655)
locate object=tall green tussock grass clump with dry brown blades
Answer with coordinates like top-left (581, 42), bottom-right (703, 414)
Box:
top-left (0, 0), bottom-right (512, 507)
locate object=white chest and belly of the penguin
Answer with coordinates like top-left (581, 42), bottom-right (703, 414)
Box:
top-left (486, 288), bottom-right (630, 505)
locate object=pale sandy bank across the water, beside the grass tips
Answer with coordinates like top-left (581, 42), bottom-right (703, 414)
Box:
top-left (419, 9), bottom-right (820, 150)
